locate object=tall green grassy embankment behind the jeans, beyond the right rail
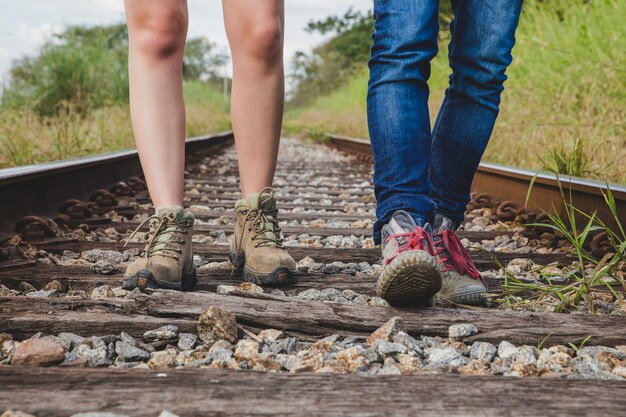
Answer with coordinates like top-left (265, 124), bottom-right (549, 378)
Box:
top-left (286, 0), bottom-right (626, 184)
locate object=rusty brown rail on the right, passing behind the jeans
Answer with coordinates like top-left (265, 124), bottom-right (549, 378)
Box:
top-left (327, 135), bottom-right (626, 227)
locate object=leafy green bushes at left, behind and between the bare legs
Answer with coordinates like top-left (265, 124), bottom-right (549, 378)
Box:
top-left (2, 23), bottom-right (228, 116)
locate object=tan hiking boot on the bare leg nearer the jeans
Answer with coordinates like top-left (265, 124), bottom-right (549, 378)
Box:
top-left (229, 188), bottom-right (297, 285)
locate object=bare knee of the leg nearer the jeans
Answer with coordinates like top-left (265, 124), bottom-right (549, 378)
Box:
top-left (233, 18), bottom-right (283, 64)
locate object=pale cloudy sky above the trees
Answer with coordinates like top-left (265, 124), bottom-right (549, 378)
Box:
top-left (0, 0), bottom-right (372, 81)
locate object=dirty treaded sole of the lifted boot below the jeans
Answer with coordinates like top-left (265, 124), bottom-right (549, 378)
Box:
top-left (376, 251), bottom-right (441, 307)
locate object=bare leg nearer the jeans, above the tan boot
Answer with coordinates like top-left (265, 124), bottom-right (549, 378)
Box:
top-left (222, 0), bottom-right (285, 198)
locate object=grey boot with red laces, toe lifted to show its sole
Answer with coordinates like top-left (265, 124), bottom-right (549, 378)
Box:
top-left (376, 210), bottom-right (441, 306)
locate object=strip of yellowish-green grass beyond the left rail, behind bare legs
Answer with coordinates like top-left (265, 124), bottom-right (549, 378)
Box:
top-left (0, 82), bottom-right (230, 168)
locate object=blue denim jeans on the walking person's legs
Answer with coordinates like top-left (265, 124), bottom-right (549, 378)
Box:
top-left (367, 0), bottom-right (522, 243)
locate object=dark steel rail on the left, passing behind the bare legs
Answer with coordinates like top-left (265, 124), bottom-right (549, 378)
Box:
top-left (0, 132), bottom-right (234, 230)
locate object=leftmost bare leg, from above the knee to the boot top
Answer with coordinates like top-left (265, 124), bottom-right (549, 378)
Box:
top-left (125, 0), bottom-right (188, 208)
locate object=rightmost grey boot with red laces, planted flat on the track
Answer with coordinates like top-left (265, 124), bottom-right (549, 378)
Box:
top-left (433, 214), bottom-right (487, 305)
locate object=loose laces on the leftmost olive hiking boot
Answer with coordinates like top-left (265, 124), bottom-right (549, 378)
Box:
top-left (124, 215), bottom-right (191, 260)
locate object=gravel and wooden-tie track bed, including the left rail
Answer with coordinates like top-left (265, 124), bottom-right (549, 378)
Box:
top-left (0, 134), bottom-right (626, 416)
